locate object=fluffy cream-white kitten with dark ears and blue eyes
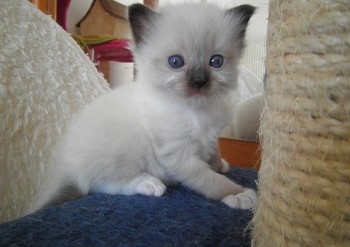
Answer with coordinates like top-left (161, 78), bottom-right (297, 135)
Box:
top-left (34, 1), bottom-right (256, 209)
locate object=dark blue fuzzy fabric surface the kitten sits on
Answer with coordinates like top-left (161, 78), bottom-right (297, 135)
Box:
top-left (0, 168), bottom-right (257, 247)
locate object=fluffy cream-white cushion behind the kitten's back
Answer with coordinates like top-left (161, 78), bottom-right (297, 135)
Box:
top-left (0, 0), bottom-right (110, 222)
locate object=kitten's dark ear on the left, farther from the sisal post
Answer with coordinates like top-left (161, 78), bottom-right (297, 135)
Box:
top-left (129, 4), bottom-right (158, 46)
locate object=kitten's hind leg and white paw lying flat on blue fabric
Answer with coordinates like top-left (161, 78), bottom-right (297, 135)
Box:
top-left (94, 173), bottom-right (166, 196)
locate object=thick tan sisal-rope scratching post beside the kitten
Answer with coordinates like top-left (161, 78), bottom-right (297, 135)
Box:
top-left (253, 0), bottom-right (350, 247)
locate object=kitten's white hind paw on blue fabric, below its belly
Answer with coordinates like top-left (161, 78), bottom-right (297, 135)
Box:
top-left (136, 174), bottom-right (166, 196)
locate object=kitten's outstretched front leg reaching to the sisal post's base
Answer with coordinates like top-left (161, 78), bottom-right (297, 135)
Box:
top-left (169, 158), bottom-right (256, 209)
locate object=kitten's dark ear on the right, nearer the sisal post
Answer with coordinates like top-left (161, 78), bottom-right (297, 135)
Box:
top-left (227, 5), bottom-right (256, 38)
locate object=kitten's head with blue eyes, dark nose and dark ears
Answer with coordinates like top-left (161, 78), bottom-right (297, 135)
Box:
top-left (129, 4), bottom-right (255, 104)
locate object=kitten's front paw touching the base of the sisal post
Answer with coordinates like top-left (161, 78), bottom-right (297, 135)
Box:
top-left (222, 189), bottom-right (256, 209)
